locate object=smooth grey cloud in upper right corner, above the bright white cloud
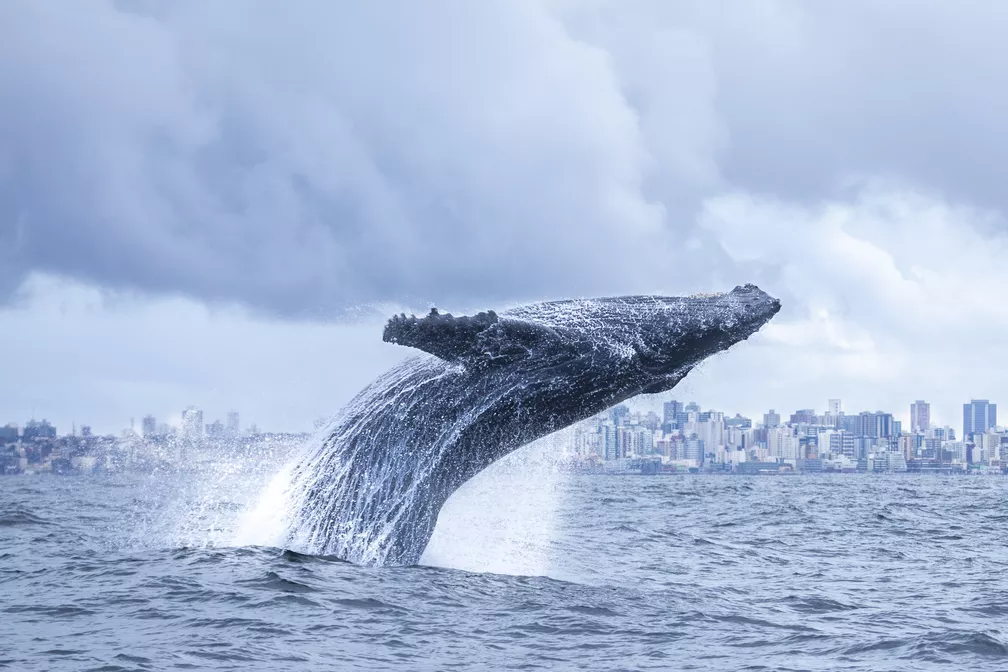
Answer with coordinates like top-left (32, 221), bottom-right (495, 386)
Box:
top-left (637, 0), bottom-right (1008, 211)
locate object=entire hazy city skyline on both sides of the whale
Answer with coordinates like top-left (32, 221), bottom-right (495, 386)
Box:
top-left (0, 398), bottom-right (1008, 475)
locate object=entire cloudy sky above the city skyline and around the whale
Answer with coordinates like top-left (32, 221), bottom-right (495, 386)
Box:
top-left (0, 0), bottom-right (1008, 432)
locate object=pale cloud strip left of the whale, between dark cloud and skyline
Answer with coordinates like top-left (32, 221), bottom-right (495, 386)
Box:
top-left (0, 274), bottom-right (405, 434)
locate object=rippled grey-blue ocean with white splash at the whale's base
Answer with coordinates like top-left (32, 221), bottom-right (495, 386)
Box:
top-left (0, 453), bottom-right (1008, 670)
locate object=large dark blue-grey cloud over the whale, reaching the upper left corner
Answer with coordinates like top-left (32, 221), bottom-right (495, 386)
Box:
top-left (0, 0), bottom-right (729, 317)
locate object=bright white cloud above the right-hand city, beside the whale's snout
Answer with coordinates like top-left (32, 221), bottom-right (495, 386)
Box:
top-left (701, 185), bottom-right (1008, 427)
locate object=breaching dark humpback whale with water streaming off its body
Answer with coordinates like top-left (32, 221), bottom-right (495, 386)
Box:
top-left (285, 285), bottom-right (780, 565)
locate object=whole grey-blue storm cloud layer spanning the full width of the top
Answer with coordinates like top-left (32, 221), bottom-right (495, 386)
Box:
top-left (0, 0), bottom-right (1008, 316)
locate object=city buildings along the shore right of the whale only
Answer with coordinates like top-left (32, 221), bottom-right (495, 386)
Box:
top-left (573, 399), bottom-right (1008, 475)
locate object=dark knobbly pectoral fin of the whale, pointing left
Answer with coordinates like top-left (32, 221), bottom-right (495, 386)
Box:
top-left (382, 308), bottom-right (557, 367)
